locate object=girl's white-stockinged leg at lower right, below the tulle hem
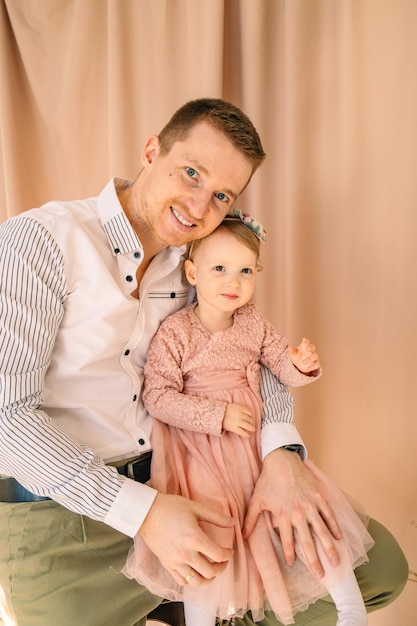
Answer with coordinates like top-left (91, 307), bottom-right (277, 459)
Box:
top-left (329, 571), bottom-right (368, 626)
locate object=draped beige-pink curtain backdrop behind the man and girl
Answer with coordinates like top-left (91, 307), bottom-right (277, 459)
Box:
top-left (0, 0), bottom-right (417, 626)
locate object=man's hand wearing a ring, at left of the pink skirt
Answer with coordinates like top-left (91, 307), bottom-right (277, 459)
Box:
top-left (139, 493), bottom-right (234, 587)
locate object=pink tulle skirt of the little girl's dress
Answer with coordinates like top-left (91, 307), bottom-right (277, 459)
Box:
top-left (123, 371), bottom-right (373, 624)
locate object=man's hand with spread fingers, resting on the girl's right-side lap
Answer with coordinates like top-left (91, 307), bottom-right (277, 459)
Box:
top-left (243, 448), bottom-right (342, 578)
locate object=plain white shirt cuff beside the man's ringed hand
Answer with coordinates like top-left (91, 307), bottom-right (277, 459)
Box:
top-left (103, 478), bottom-right (158, 538)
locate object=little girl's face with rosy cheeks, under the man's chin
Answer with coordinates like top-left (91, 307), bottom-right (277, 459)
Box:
top-left (184, 230), bottom-right (258, 313)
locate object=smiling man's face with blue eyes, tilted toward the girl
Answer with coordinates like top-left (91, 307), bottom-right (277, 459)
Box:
top-left (138, 122), bottom-right (252, 246)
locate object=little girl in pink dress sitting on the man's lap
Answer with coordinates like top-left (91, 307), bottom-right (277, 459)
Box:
top-left (124, 211), bottom-right (373, 626)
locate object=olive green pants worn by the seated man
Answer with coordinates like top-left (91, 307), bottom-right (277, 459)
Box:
top-left (0, 501), bottom-right (408, 626)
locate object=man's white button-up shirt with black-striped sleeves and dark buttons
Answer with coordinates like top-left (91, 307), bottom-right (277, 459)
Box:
top-left (0, 181), bottom-right (301, 536)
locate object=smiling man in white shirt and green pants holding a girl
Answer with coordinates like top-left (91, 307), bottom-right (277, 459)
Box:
top-left (0, 99), bottom-right (406, 626)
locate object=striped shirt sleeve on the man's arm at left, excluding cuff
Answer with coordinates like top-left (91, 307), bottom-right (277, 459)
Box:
top-left (0, 216), bottom-right (124, 520)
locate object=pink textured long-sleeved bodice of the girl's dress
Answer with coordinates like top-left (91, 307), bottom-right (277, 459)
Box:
top-left (143, 304), bottom-right (315, 435)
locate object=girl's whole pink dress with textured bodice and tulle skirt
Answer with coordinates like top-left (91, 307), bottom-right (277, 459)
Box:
top-left (123, 304), bottom-right (372, 624)
